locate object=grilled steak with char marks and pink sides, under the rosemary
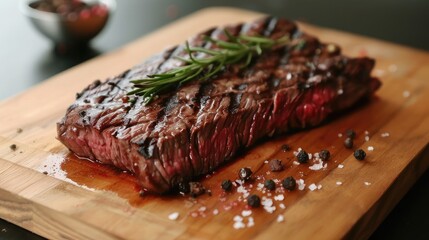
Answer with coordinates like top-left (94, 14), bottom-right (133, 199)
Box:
top-left (58, 17), bottom-right (380, 193)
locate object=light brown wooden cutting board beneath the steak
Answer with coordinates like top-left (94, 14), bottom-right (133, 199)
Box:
top-left (0, 8), bottom-right (429, 239)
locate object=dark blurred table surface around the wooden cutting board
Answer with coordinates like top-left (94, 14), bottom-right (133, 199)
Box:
top-left (0, 0), bottom-right (429, 239)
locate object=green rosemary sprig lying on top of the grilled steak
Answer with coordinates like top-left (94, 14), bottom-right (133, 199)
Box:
top-left (128, 31), bottom-right (289, 104)
